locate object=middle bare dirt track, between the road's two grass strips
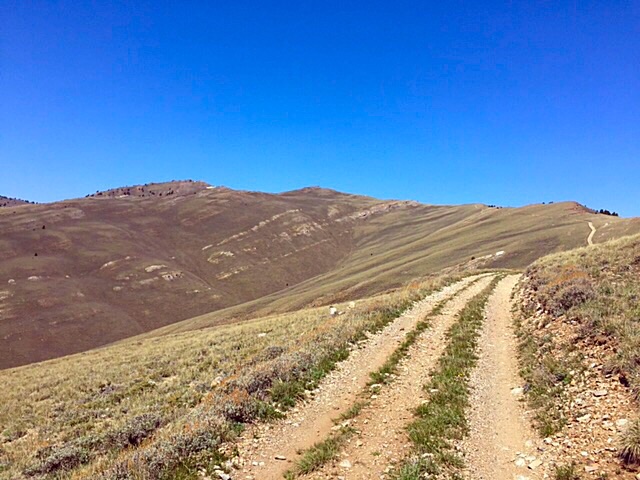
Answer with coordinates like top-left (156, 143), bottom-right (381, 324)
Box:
top-left (304, 277), bottom-right (490, 480)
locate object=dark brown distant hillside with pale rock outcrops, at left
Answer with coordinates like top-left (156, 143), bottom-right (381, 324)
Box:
top-left (0, 182), bottom-right (415, 368)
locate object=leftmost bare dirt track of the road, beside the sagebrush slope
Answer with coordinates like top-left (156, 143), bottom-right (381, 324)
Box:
top-left (234, 277), bottom-right (487, 480)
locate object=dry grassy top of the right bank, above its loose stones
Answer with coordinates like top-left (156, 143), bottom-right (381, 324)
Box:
top-left (526, 235), bottom-right (640, 384)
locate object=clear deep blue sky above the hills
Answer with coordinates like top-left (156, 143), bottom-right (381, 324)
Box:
top-left (0, 0), bottom-right (640, 216)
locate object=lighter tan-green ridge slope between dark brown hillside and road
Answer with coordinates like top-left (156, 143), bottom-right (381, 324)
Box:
top-left (138, 202), bottom-right (640, 336)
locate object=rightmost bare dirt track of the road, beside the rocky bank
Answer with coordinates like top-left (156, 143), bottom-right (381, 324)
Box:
top-left (462, 275), bottom-right (542, 480)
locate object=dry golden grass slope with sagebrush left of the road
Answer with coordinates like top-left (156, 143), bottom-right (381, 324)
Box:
top-left (0, 278), bottom-right (460, 478)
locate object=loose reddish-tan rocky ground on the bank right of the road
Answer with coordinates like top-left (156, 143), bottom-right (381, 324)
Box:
top-left (520, 284), bottom-right (640, 480)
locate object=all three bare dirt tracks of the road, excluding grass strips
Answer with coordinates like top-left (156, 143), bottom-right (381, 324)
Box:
top-left (233, 275), bottom-right (542, 480)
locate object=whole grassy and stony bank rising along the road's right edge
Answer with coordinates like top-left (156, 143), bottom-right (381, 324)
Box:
top-left (519, 235), bottom-right (640, 478)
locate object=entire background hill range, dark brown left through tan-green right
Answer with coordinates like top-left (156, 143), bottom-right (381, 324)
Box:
top-left (0, 182), bottom-right (640, 368)
